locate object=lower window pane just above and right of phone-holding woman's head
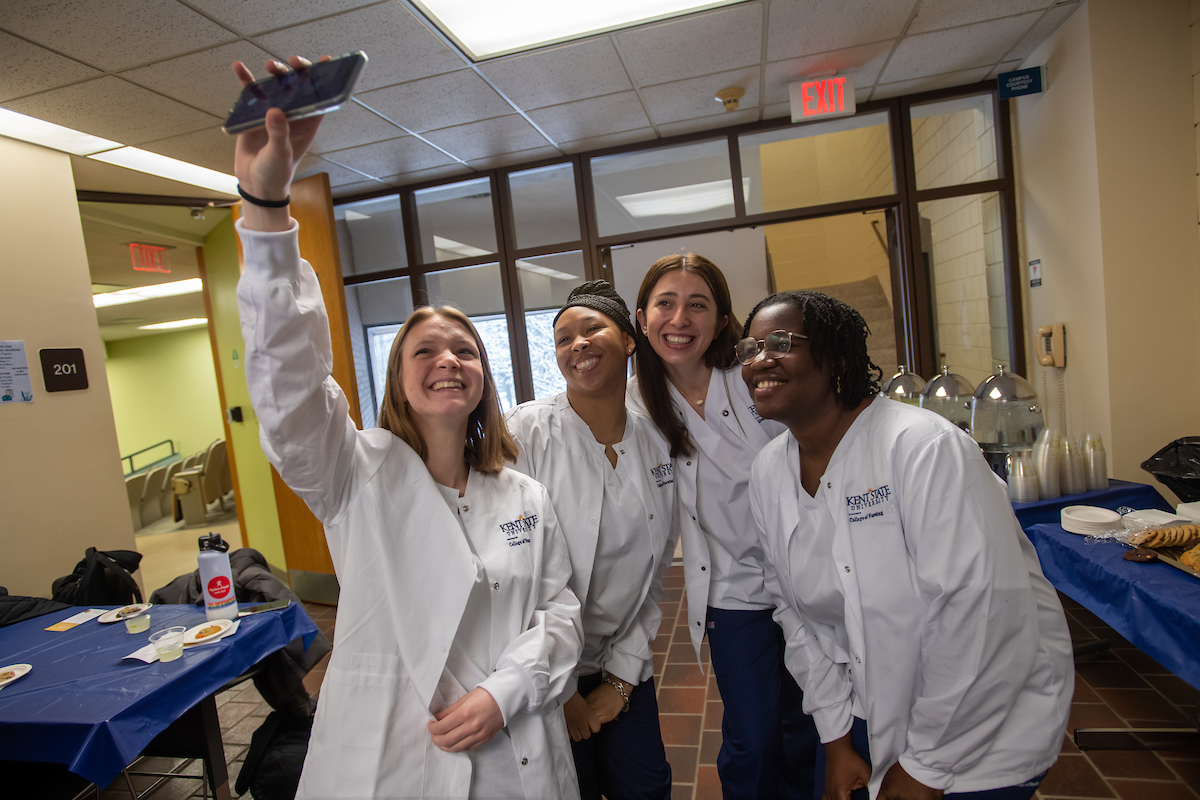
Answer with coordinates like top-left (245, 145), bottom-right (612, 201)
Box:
top-left (425, 264), bottom-right (517, 411)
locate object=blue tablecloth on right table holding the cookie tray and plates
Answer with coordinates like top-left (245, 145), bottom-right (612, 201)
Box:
top-left (1025, 523), bottom-right (1200, 688)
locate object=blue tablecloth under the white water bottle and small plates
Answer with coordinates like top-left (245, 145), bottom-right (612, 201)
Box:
top-left (0, 603), bottom-right (317, 787)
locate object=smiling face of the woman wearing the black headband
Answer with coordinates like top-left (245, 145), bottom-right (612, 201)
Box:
top-left (554, 306), bottom-right (634, 395)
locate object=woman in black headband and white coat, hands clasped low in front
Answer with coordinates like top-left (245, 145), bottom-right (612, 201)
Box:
top-left (508, 281), bottom-right (676, 800)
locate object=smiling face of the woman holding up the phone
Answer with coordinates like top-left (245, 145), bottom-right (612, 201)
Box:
top-left (400, 315), bottom-right (484, 428)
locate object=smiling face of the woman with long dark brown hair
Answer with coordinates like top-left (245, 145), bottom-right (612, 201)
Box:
top-left (637, 270), bottom-right (728, 372)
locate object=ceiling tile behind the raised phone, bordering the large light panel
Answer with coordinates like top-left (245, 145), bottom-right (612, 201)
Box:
top-left (256, 2), bottom-right (463, 91)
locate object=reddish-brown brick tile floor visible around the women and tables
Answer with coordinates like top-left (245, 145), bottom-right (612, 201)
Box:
top-left (102, 566), bottom-right (1200, 800)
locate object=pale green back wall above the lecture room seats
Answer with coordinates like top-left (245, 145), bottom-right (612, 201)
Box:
top-left (104, 327), bottom-right (224, 467)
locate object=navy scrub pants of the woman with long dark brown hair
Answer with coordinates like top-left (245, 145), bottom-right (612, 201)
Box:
top-left (707, 607), bottom-right (821, 800)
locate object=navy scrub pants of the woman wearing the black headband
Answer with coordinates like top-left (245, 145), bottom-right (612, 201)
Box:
top-left (571, 673), bottom-right (671, 800)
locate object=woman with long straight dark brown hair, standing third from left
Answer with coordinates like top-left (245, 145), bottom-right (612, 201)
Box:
top-left (629, 253), bottom-right (817, 800)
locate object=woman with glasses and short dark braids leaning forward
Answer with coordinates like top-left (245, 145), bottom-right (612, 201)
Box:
top-left (737, 291), bottom-right (1074, 800)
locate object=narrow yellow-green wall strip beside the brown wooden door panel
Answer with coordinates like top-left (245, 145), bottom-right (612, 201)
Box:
top-left (204, 218), bottom-right (287, 570)
